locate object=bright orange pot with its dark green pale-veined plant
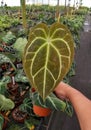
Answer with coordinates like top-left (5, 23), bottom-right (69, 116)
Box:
top-left (30, 91), bottom-right (73, 117)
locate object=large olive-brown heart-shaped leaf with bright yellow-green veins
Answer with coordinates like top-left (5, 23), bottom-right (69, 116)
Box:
top-left (23, 23), bottom-right (74, 99)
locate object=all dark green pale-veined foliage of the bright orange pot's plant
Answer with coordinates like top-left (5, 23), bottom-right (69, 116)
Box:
top-left (32, 92), bottom-right (73, 116)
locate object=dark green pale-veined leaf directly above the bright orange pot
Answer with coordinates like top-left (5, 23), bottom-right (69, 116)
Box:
top-left (33, 92), bottom-right (66, 111)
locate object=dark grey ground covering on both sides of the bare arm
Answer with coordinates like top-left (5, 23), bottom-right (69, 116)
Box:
top-left (41, 15), bottom-right (91, 130)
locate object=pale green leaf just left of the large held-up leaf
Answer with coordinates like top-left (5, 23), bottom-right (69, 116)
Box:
top-left (13, 38), bottom-right (27, 58)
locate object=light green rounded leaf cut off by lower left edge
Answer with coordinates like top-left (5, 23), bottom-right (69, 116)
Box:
top-left (0, 94), bottom-right (14, 111)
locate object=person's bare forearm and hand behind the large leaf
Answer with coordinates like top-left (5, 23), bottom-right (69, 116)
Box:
top-left (55, 82), bottom-right (91, 130)
